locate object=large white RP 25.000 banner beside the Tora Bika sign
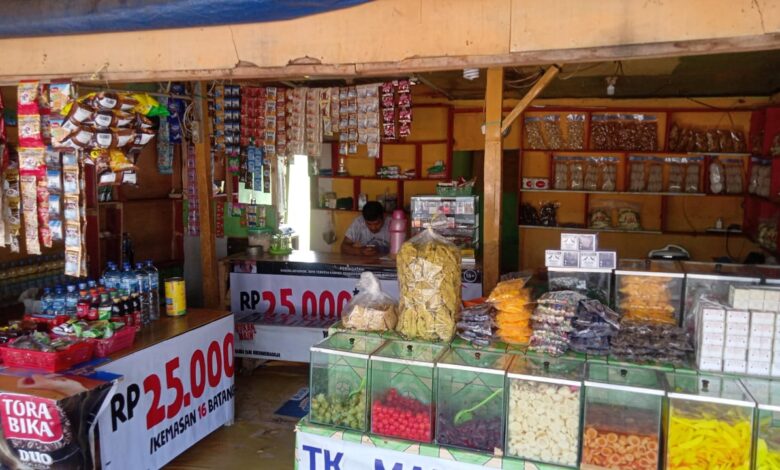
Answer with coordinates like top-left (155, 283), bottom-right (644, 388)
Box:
top-left (99, 315), bottom-right (235, 469)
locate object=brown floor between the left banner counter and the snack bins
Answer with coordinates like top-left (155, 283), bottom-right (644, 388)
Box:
top-left (165, 363), bottom-right (309, 470)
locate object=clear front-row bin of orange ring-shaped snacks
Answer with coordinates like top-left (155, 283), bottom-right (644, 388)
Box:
top-left (580, 363), bottom-right (665, 470)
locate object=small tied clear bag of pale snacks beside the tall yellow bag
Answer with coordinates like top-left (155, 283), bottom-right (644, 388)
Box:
top-left (342, 271), bottom-right (398, 331)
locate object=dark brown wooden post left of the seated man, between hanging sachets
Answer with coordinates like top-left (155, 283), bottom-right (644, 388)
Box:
top-left (195, 82), bottom-right (219, 308)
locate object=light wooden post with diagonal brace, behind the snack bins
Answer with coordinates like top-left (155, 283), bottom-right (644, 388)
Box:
top-left (482, 67), bottom-right (504, 294)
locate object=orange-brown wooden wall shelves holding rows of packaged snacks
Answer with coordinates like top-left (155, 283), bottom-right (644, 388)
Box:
top-left (518, 108), bottom-right (760, 236)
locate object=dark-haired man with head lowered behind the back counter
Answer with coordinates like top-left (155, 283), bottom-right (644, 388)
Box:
top-left (341, 201), bottom-right (390, 256)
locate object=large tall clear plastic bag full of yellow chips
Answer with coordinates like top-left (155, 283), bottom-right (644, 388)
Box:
top-left (397, 228), bottom-right (461, 341)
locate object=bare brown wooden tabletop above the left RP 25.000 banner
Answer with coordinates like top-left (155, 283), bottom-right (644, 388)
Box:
top-left (108, 308), bottom-right (231, 361)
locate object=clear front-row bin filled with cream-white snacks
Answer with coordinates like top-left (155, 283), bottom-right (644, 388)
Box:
top-left (505, 353), bottom-right (585, 467)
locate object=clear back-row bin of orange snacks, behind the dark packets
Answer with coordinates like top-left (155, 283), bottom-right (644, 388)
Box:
top-left (615, 259), bottom-right (685, 325)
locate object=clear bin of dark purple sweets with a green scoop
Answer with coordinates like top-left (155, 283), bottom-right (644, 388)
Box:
top-left (436, 348), bottom-right (512, 455)
